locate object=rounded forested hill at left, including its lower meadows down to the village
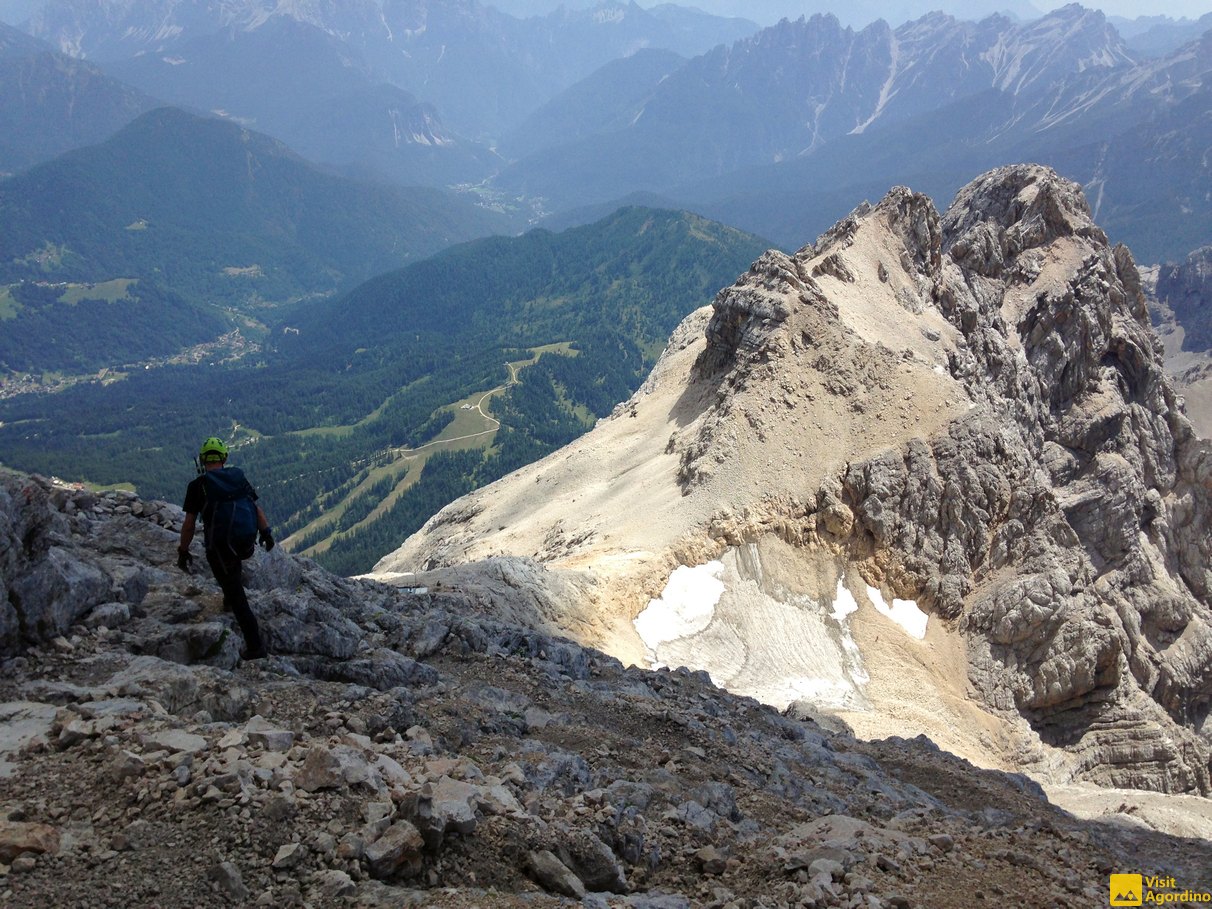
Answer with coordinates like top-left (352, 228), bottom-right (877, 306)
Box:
top-left (0, 108), bottom-right (511, 370)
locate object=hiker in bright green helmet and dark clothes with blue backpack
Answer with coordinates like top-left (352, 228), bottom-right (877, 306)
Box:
top-left (177, 436), bottom-right (274, 659)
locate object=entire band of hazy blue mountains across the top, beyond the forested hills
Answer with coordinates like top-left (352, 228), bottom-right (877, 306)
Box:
top-left (8, 0), bottom-right (1212, 261)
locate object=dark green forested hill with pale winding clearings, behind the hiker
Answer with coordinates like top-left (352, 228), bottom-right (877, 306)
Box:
top-left (0, 208), bottom-right (767, 572)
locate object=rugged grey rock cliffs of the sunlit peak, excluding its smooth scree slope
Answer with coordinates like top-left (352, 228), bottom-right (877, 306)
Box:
top-left (682, 166), bottom-right (1212, 793)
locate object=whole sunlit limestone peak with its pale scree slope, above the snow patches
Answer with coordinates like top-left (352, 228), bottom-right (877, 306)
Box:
top-left (382, 166), bottom-right (1212, 793)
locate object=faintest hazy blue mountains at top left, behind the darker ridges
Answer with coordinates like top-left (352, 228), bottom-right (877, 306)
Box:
top-left (29, 0), bottom-right (756, 138)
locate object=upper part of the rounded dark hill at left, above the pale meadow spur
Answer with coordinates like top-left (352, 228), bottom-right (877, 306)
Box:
top-left (0, 108), bottom-right (507, 349)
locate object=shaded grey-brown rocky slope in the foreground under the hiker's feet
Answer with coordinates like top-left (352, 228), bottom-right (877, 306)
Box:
top-left (0, 474), bottom-right (1212, 909)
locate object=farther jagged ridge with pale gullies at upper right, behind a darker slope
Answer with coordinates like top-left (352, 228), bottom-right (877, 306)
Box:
top-left (492, 6), bottom-right (1130, 206)
